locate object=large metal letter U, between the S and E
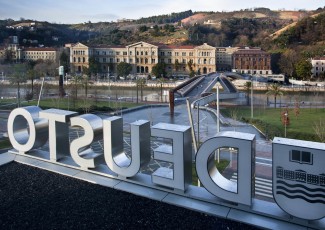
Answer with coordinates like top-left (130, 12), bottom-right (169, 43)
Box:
top-left (103, 117), bottom-right (150, 178)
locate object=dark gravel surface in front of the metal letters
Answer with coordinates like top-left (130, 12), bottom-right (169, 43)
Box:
top-left (0, 162), bottom-right (255, 230)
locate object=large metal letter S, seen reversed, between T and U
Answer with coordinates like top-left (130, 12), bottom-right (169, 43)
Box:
top-left (70, 114), bottom-right (104, 169)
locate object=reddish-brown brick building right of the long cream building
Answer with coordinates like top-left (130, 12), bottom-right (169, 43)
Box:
top-left (232, 47), bottom-right (272, 75)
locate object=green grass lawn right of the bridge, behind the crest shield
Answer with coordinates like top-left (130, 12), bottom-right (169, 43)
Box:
top-left (220, 107), bottom-right (325, 141)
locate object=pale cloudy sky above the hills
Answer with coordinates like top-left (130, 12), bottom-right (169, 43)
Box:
top-left (0, 0), bottom-right (325, 24)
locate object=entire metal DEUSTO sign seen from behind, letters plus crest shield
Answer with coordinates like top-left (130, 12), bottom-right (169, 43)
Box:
top-left (8, 106), bottom-right (325, 220)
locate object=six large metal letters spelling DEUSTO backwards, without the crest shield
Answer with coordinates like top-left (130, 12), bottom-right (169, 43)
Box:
top-left (8, 106), bottom-right (255, 205)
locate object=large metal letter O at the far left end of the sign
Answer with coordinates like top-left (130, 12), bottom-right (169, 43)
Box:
top-left (8, 106), bottom-right (48, 154)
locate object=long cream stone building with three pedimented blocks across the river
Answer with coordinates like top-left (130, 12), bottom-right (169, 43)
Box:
top-left (66, 42), bottom-right (216, 76)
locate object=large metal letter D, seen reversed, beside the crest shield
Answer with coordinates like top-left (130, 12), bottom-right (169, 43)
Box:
top-left (196, 132), bottom-right (255, 206)
